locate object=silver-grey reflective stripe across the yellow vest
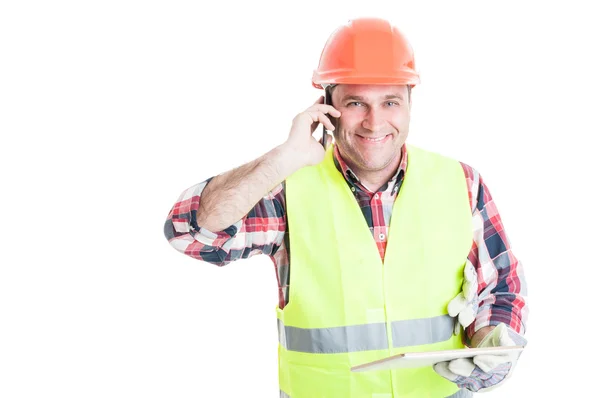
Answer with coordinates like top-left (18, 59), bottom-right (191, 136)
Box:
top-left (277, 315), bottom-right (454, 354)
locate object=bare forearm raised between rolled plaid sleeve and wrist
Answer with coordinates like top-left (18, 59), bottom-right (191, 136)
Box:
top-left (196, 145), bottom-right (302, 231)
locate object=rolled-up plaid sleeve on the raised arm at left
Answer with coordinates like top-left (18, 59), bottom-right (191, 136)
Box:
top-left (164, 177), bottom-right (286, 266)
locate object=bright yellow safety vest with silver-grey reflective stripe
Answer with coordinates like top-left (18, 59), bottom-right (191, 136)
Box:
top-left (277, 146), bottom-right (473, 398)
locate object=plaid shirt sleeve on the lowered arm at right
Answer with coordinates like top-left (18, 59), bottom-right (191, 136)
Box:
top-left (461, 163), bottom-right (528, 339)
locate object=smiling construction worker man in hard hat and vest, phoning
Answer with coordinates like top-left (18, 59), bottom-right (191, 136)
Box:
top-left (165, 19), bottom-right (527, 398)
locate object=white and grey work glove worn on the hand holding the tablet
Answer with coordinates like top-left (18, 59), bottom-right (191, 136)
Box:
top-left (433, 323), bottom-right (527, 392)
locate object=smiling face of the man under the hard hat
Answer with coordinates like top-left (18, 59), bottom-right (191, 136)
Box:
top-left (332, 84), bottom-right (410, 174)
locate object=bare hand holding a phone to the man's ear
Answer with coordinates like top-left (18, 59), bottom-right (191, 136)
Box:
top-left (282, 96), bottom-right (342, 167)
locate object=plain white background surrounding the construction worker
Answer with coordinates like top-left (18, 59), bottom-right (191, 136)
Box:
top-left (0, 1), bottom-right (600, 398)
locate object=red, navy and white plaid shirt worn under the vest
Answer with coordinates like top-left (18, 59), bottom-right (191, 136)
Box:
top-left (165, 146), bottom-right (528, 338)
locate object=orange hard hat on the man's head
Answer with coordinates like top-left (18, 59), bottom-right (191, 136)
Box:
top-left (312, 18), bottom-right (420, 88)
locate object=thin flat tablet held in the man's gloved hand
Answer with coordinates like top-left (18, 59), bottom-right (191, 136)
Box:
top-left (350, 345), bottom-right (524, 372)
